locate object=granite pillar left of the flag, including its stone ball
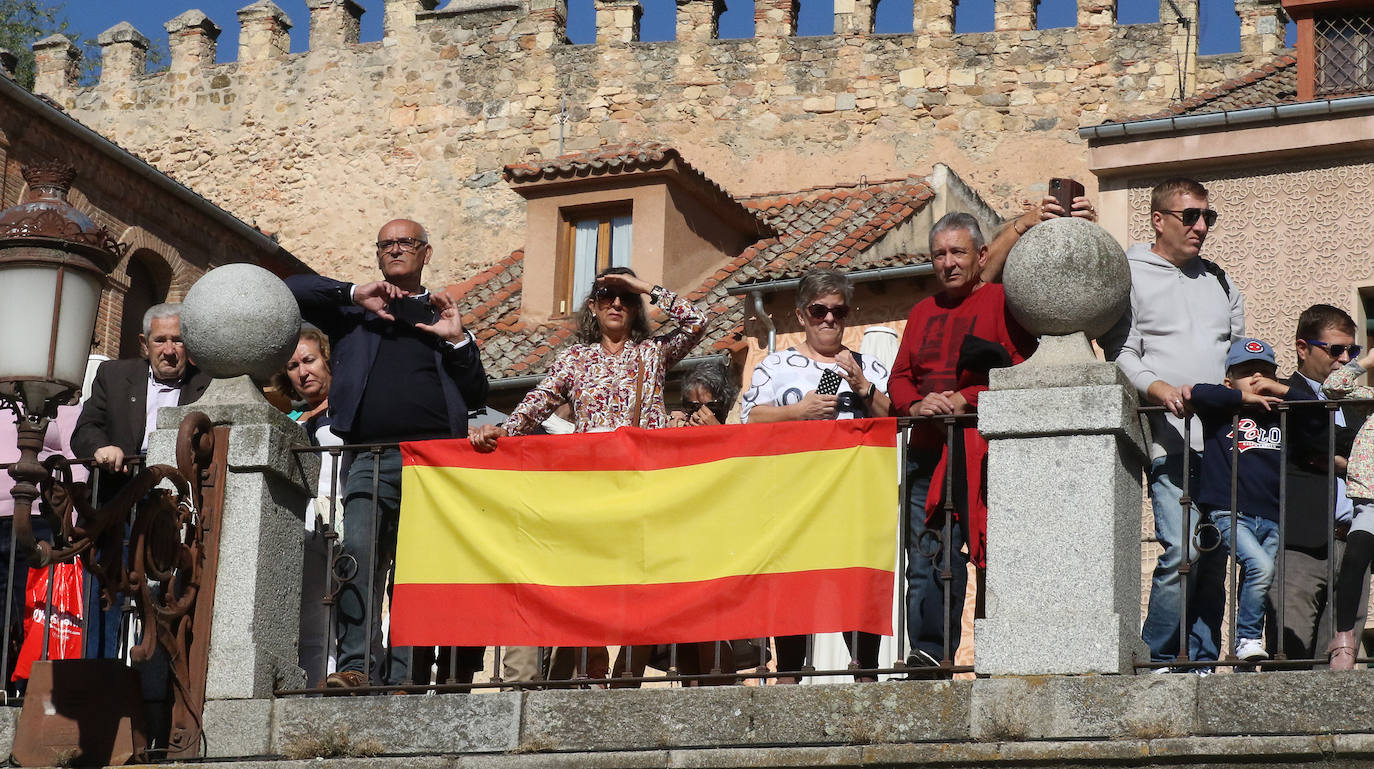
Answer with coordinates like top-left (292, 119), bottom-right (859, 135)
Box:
top-left (148, 264), bottom-right (309, 757)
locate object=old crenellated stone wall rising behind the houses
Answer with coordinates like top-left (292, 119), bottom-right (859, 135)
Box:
top-left (38, 0), bottom-right (1282, 288)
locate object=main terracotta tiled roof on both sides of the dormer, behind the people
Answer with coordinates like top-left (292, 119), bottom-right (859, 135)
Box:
top-left (449, 173), bottom-right (934, 379)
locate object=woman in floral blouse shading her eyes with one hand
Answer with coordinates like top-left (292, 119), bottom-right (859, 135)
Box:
top-left (469, 266), bottom-right (708, 685)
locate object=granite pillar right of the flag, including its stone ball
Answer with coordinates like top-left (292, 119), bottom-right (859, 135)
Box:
top-left (974, 218), bottom-right (1146, 676)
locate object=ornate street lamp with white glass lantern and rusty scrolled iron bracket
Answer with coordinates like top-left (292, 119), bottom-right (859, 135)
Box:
top-left (0, 162), bottom-right (228, 766)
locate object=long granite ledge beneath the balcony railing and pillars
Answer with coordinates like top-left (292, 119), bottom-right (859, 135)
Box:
top-left (21, 672), bottom-right (1374, 769)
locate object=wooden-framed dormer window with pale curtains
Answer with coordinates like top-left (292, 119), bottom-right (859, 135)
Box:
top-left (554, 203), bottom-right (633, 314)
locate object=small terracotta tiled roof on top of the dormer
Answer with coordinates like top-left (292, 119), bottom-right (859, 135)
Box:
top-left (504, 141), bottom-right (772, 236)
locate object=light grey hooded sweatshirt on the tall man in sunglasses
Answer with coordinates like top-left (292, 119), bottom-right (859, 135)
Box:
top-left (1099, 243), bottom-right (1245, 459)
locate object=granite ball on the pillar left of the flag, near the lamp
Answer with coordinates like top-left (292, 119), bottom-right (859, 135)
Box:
top-left (181, 264), bottom-right (301, 382)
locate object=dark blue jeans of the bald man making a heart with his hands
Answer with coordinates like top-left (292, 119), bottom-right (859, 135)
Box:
top-left (335, 449), bottom-right (411, 684)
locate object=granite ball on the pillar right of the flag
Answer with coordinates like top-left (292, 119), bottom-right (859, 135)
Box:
top-left (1002, 217), bottom-right (1131, 339)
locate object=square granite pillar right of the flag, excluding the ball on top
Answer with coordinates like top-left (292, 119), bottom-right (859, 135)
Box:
top-left (974, 363), bottom-right (1146, 676)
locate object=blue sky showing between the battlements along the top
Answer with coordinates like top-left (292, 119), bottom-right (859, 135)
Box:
top-left (66, 0), bottom-right (1292, 62)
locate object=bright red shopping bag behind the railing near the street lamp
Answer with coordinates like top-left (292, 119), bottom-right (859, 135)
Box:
top-left (11, 562), bottom-right (81, 681)
